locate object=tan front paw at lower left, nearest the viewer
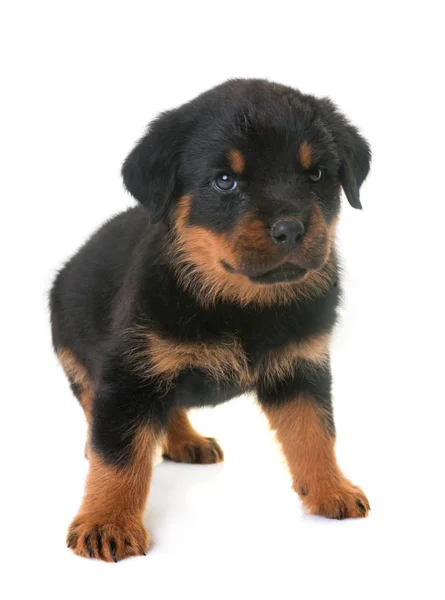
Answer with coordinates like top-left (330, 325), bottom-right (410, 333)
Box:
top-left (67, 515), bottom-right (150, 562)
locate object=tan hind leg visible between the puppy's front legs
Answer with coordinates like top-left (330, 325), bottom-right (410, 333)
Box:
top-left (163, 408), bottom-right (224, 464)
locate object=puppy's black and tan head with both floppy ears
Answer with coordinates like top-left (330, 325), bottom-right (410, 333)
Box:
top-left (122, 80), bottom-right (370, 302)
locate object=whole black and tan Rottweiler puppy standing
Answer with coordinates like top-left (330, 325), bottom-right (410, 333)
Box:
top-left (50, 80), bottom-right (370, 561)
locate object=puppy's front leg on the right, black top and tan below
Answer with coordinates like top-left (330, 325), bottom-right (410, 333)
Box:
top-left (258, 361), bottom-right (370, 519)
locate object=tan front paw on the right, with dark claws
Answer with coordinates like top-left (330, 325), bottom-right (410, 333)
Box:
top-left (297, 480), bottom-right (371, 519)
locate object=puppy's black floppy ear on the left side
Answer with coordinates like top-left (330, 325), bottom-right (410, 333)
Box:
top-left (122, 107), bottom-right (189, 223)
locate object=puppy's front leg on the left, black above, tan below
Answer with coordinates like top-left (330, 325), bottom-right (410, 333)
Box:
top-left (67, 366), bottom-right (168, 562)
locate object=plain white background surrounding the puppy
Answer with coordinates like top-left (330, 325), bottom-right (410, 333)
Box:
top-left (0, 0), bottom-right (445, 600)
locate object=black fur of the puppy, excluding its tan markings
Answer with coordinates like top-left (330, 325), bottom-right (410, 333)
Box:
top-left (51, 80), bottom-right (370, 465)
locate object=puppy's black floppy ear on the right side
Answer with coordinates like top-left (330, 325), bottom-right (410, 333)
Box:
top-left (321, 98), bottom-right (371, 208)
